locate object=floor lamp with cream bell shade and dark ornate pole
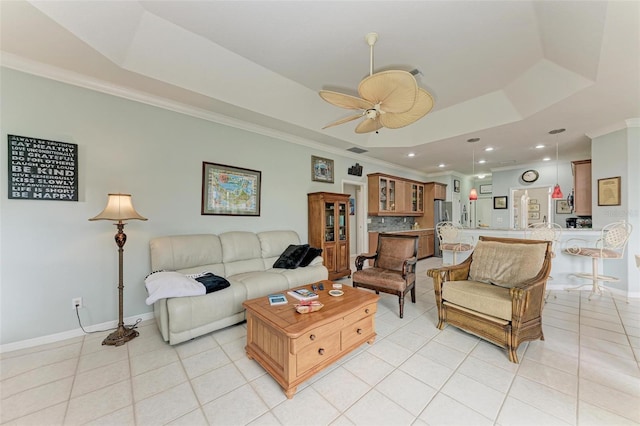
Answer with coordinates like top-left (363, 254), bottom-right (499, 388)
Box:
top-left (89, 194), bottom-right (147, 346)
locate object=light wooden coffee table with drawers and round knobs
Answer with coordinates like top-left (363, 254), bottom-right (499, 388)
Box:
top-left (243, 281), bottom-right (379, 399)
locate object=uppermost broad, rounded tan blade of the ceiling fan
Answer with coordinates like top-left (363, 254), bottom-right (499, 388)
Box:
top-left (358, 70), bottom-right (418, 113)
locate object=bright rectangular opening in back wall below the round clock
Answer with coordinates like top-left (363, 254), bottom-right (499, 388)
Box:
top-left (509, 186), bottom-right (554, 229)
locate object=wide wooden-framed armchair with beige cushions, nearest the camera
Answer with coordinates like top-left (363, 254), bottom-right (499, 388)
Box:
top-left (427, 236), bottom-right (552, 363)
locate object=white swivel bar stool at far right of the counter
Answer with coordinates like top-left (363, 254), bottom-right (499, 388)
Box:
top-left (564, 220), bottom-right (633, 300)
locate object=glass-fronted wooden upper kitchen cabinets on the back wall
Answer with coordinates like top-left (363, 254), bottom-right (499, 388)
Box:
top-left (367, 173), bottom-right (424, 216)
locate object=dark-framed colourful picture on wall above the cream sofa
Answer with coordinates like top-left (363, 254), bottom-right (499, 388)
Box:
top-left (200, 161), bottom-right (262, 216)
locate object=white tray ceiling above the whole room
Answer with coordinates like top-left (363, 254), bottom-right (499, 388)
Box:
top-left (0, 1), bottom-right (640, 174)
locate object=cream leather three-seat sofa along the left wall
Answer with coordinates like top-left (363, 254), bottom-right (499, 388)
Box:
top-left (149, 231), bottom-right (329, 345)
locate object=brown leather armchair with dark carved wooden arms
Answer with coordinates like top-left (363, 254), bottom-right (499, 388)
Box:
top-left (352, 234), bottom-right (418, 318)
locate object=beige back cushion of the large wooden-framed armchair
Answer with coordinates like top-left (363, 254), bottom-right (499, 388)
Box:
top-left (469, 241), bottom-right (547, 287)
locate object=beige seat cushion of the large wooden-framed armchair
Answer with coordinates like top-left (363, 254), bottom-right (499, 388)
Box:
top-left (442, 281), bottom-right (512, 321)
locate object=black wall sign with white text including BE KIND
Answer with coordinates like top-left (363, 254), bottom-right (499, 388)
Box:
top-left (7, 135), bottom-right (78, 201)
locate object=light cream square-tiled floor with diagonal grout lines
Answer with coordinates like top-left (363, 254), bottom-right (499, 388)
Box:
top-left (0, 259), bottom-right (640, 426)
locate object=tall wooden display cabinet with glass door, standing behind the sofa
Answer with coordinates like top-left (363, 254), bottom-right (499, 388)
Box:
top-left (307, 192), bottom-right (351, 280)
